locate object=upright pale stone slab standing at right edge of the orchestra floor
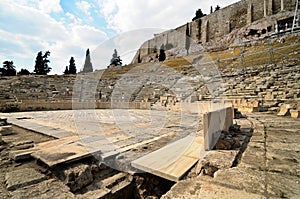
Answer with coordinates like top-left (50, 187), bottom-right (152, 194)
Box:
top-left (203, 107), bottom-right (233, 150)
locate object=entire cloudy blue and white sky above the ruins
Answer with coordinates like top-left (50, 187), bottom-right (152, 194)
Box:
top-left (0, 0), bottom-right (238, 74)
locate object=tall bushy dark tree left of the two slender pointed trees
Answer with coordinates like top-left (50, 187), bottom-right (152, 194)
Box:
top-left (34, 51), bottom-right (52, 75)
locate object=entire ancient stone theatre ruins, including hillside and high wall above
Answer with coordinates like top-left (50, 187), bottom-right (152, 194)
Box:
top-left (0, 0), bottom-right (300, 199)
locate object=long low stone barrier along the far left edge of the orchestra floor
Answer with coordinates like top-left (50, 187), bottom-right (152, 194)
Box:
top-left (0, 101), bottom-right (151, 112)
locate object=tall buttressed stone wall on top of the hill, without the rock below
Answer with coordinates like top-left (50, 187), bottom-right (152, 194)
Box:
top-left (133, 0), bottom-right (296, 63)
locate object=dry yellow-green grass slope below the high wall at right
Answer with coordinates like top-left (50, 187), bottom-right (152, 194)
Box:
top-left (200, 36), bottom-right (300, 68)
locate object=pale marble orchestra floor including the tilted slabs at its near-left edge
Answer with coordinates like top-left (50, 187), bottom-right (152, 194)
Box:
top-left (4, 109), bottom-right (202, 169)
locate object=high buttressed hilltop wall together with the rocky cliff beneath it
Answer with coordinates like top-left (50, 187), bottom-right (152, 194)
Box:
top-left (133, 0), bottom-right (299, 63)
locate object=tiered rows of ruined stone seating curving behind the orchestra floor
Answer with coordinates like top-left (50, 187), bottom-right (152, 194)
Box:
top-left (0, 60), bottom-right (300, 112)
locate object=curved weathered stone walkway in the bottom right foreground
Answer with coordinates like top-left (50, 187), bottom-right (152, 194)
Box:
top-left (163, 113), bottom-right (300, 199)
